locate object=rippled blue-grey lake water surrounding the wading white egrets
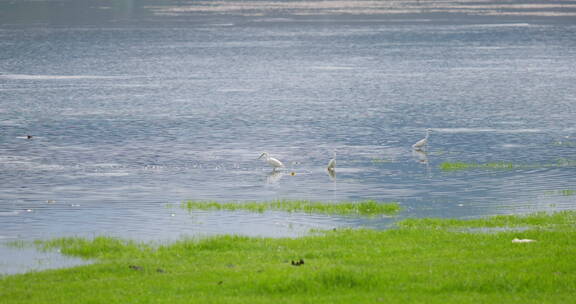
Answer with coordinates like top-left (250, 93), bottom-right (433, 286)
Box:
top-left (0, 1), bottom-right (576, 273)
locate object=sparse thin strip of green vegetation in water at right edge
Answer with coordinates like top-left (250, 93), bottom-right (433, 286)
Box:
top-left (440, 158), bottom-right (576, 171)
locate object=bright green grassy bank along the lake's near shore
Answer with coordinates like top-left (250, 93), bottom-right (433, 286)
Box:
top-left (0, 212), bottom-right (576, 303)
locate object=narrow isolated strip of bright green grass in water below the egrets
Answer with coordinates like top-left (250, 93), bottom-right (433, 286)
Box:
top-left (183, 200), bottom-right (400, 216)
